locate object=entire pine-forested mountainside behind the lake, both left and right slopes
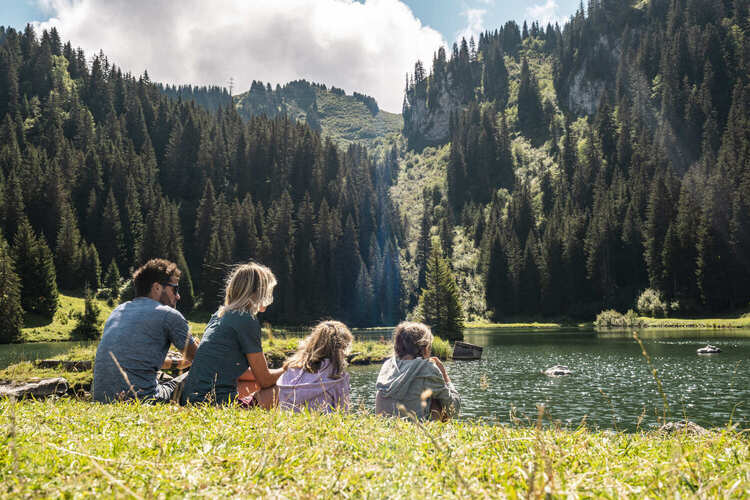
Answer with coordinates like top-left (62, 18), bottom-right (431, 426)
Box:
top-left (0, 0), bottom-right (750, 340)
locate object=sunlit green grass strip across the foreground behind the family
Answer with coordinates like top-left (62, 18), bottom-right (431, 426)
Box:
top-left (0, 399), bottom-right (750, 498)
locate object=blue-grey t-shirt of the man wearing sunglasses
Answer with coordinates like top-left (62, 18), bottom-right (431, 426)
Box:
top-left (93, 297), bottom-right (193, 402)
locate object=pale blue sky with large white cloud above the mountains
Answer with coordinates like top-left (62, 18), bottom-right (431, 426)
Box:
top-left (0, 0), bottom-right (580, 113)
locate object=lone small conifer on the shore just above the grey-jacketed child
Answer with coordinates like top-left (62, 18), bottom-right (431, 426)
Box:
top-left (418, 245), bottom-right (464, 340)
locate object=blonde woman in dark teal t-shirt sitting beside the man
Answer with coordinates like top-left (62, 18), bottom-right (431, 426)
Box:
top-left (181, 262), bottom-right (284, 408)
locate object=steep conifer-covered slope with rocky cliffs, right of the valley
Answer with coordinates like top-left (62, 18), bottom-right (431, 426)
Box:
top-left (404, 0), bottom-right (750, 320)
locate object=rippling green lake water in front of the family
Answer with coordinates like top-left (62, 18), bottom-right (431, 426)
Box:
top-left (0, 329), bottom-right (750, 431)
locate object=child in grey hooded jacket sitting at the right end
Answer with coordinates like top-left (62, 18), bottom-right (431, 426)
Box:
top-left (375, 322), bottom-right (461, 420)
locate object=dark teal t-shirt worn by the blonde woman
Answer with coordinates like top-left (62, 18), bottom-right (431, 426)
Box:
top-left (181, 311), bottom-right (263, 404)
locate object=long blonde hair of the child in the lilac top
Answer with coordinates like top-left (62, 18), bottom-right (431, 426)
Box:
top-left (284, 321), bottom-right (354, 378)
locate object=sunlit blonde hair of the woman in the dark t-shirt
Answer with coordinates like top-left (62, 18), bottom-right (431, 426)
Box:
top-left (219, 262), bottom-right (276, 317)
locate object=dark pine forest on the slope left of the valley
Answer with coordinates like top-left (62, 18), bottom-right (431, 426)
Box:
top-left (0, 26), bottom-right (403, 344)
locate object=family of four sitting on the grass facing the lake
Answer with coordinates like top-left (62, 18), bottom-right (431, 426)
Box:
top-left (93, 259), bottom-right (461, 420)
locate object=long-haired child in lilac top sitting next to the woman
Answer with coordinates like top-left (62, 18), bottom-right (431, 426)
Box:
top-left (278, 321), bottom-right (354, 413)
